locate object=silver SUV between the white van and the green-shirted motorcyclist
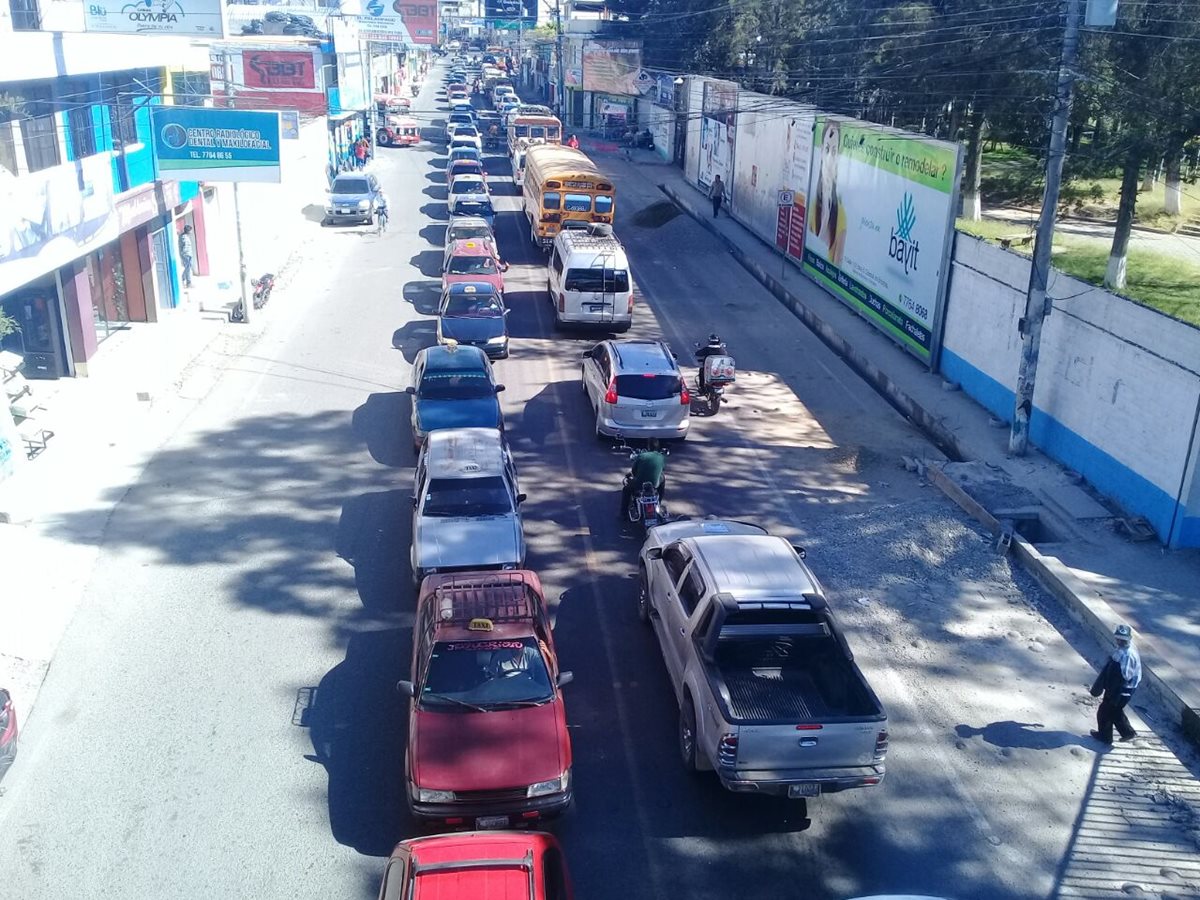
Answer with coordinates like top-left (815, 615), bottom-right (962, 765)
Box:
top-left (581, 341), bottom-right (691, 440)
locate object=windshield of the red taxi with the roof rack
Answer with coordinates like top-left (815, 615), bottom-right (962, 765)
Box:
top-left (420, 636), bottom-right (554, 710)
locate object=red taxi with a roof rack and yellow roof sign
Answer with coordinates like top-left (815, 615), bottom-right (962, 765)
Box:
top-left (400, 578), bottom-right (572, 829)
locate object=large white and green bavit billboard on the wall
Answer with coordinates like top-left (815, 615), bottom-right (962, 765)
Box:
top-left (804, 116), bottom-right (959, 364)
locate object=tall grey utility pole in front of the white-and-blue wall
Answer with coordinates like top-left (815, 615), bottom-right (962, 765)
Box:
top-left (1008, 0), bottom-right (1084, 456)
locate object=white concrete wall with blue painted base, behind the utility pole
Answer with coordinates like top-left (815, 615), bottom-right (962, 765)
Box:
top-left (941, 233), bottom-right (1200, 546)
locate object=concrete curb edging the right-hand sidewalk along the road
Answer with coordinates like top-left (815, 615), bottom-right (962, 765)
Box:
top-left (659, 177), bottom-right (1200, 746)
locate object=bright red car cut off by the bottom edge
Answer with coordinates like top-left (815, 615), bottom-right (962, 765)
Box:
top-left (379, 832), bottom-right (575, 900)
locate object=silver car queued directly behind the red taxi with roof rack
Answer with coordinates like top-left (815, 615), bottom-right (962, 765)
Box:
top-left (410, 429), bottom-right (526, 584)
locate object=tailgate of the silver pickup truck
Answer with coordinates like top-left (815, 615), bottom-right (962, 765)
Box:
top-left (737, 721), bottom-right (886, 772)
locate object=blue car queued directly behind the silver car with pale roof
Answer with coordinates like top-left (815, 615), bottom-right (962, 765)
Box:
top-left (407, 342), bottom-right (504, 451)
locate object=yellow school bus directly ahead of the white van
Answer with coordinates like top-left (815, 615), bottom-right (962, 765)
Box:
top-left (522, 144), bottom-right (616, 250)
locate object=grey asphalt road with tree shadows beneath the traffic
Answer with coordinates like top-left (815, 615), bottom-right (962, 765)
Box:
top-left (0, 65), bottom-right (1190, 900)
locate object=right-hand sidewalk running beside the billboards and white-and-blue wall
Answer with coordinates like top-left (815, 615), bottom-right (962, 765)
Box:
top-left (604, 156), bottom-right (1200, 744)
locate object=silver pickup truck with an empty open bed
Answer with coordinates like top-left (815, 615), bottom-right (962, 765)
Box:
top-left (638, 518), bottom-right (888, 798)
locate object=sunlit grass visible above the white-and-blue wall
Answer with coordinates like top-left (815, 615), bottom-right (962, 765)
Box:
top-left (956, 218), bottom-right (1200, 326)
